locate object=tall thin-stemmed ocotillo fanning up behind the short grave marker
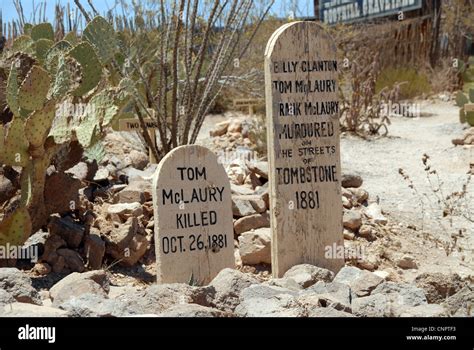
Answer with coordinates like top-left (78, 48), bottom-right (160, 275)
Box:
top-left (96, 0), bottom-right (273, 161)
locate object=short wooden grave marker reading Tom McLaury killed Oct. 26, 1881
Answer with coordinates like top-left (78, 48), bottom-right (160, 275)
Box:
top-left (153, 145), bottom-right (235, 285)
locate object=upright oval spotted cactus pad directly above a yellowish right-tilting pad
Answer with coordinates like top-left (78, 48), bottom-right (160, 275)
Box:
top-left (19, 66), bottom-right (51, 111)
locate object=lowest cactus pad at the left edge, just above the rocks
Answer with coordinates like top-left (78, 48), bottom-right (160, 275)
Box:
top-left (0, 207), bottom-right (31, 246)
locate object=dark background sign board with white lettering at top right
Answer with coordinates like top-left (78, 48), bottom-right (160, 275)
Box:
top-left (319, 0), bottom-right (422, 24)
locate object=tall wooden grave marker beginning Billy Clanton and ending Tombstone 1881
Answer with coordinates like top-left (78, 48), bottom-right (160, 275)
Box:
top-left (265, 22), bottom-right (344, 277)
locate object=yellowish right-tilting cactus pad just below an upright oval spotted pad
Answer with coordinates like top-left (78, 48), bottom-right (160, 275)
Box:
top-left (25, 100), bottom-right (56, 148)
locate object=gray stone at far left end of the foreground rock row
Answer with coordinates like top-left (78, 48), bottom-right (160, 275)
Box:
top-left (0, 267), bottom-right (42, 305)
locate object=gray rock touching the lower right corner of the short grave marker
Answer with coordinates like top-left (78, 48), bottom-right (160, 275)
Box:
top-left (209, 269), bottom-right (258, 312)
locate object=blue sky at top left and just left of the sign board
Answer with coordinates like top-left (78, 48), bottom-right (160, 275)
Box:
top-left (0, 0), bottom-right (313, 22)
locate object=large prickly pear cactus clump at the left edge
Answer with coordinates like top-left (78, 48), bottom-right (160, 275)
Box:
top-left (0, 17), bottom-right (127, 244)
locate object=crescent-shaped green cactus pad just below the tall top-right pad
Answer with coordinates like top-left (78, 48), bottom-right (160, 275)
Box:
top-left (68, 42), bottom-right (102, 96)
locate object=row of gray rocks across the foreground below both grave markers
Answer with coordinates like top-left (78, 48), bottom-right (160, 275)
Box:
top-left (0, 264), bottom-right (474, 317)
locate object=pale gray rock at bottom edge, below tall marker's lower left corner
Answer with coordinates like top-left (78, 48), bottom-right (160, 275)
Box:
top-left (235, 285), bottom-right (304, 317)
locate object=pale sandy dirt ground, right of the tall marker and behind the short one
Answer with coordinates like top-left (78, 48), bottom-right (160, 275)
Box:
top-left (198, 100), bottom-right (474, 281)
